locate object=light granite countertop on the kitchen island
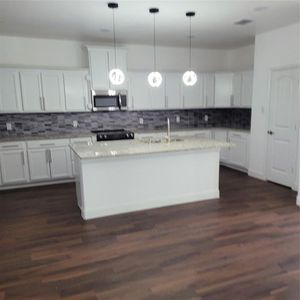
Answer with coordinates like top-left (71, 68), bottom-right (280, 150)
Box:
top-left (71, 137), bottom-right (232, 160)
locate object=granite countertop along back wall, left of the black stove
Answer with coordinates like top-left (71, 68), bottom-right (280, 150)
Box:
top-left (0, 133), bottom-right (95, 143)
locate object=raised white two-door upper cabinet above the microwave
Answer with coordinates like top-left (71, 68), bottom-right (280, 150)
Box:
top-left (87, 47), bottom-right (128, 91)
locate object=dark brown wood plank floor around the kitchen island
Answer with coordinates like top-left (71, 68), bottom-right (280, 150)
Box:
top-left (0, 168), bottom-right (300, 300)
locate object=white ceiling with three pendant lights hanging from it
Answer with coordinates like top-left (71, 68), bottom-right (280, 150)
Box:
top-left (0, 0), bottom-right (300, 49)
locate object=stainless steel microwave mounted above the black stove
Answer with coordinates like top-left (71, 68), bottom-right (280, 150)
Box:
top-left (92, 91), bottom-right (127, 111)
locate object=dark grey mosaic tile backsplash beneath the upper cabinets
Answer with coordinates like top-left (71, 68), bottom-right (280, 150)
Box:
top-left (0, 108), bottom-right (251, 138)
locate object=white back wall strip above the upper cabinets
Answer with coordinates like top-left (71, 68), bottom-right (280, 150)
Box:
top-left (0, 36), bottom-right (254, 71)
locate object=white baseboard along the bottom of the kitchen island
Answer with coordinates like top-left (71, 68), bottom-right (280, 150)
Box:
top-left (81, 190), bottom-right (220, 220)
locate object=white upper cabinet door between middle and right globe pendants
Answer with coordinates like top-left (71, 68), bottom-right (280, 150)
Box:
top-left (165, 73), bottom-right (183, 109)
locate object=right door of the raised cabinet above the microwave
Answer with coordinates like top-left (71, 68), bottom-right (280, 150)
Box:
top-left (107, 49), bottom-right (128, 90)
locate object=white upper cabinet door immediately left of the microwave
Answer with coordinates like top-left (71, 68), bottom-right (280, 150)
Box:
top-left (63, 71), bottom-right (90, 111)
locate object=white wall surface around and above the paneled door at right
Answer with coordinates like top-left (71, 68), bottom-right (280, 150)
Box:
top-left (249, 23), bottom-right (300, 179)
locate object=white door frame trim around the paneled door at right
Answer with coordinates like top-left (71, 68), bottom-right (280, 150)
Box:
top-left (265, 64), bottom-right (300, 190)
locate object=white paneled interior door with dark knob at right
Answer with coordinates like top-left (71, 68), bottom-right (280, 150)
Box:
top-left (267, 69), bottom-right (300, 186)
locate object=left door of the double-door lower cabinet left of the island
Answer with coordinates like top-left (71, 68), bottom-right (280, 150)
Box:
top-left (28, 148), bottom-right (50, 181)
